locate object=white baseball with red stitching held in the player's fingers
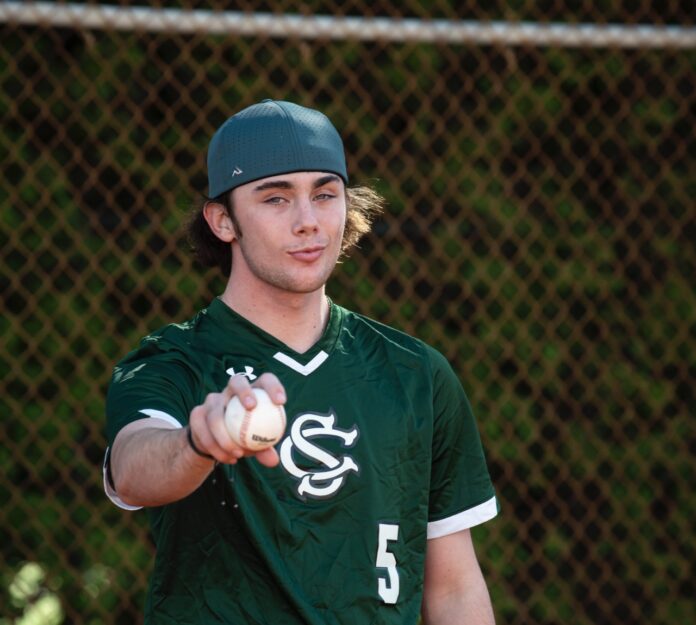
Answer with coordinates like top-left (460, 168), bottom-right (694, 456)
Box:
top-left (225, 388), bottom-right (285, 451)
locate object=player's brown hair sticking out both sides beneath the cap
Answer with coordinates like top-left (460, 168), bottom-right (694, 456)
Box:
top-left (186, 186), bottom-right (384, 276)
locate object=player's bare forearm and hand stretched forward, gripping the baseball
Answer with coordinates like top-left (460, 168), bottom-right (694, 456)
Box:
top-left (111, 374), bottom-right (285, 506)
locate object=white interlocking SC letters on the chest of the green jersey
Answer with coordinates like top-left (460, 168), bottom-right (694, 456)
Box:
top-left (280, 412), bottom-right (360, 499)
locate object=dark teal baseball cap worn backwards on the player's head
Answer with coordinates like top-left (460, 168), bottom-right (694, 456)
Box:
top-left (208, 100), bottom-right (348, 198)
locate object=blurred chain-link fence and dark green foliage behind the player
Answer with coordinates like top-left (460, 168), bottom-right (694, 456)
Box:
top-left (0, 0), bottom-right (696, 625)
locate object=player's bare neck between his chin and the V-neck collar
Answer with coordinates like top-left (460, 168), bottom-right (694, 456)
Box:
top-left (220, 280), bottom-right (329, 354)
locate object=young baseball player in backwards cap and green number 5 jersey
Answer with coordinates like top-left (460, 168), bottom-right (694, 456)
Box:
top-left (105, 100), bottom-right (497, 625)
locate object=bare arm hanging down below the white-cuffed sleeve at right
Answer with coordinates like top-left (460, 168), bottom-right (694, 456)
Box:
top-left (423, 530), bottom-right (495, 625)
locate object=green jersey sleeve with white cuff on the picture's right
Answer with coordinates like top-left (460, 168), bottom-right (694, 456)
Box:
top-left (428, 349), bottom-right (498, 538)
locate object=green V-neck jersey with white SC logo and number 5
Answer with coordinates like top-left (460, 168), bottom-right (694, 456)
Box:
top-left (105, 300), bottom-right (497, 625)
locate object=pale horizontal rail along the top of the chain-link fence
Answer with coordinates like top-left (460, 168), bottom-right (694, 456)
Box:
top-left (0, 1), bottom-right (696, 48)
